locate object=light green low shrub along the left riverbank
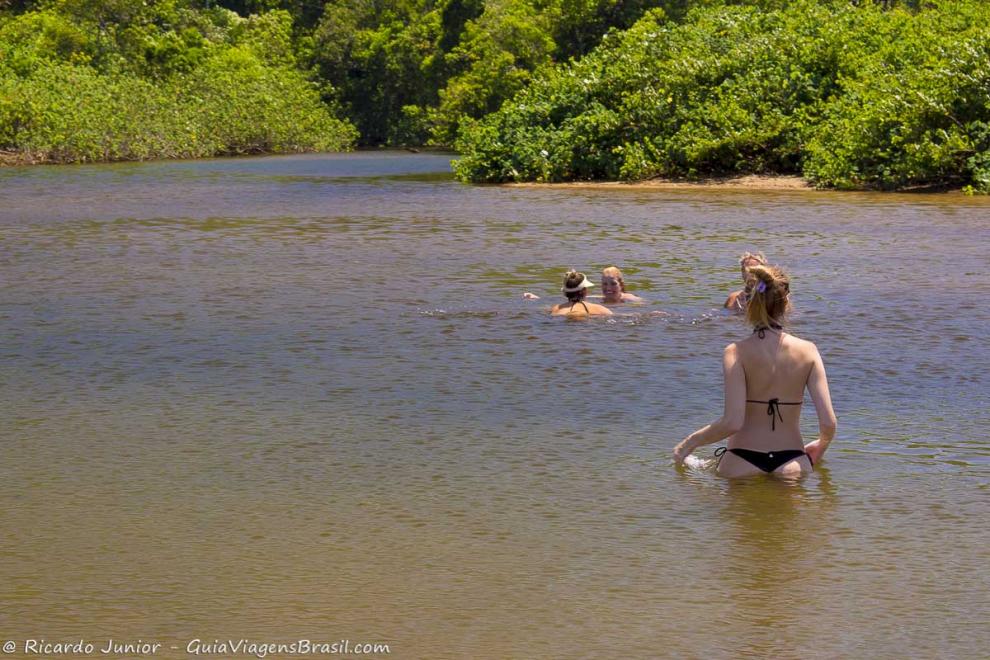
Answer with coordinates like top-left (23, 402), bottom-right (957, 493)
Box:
top-left (0, 10), bottom-right (357, 162)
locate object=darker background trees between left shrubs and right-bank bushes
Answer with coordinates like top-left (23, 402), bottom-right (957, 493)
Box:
top-left (309, 0), bottom-right (705, 145)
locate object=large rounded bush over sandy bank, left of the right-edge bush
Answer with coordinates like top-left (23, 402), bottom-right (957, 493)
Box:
top-left (457, 6), bottom-right (834, 181)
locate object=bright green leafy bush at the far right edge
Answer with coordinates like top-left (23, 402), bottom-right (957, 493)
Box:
top-left (804, 3), bottom-right (990, 192)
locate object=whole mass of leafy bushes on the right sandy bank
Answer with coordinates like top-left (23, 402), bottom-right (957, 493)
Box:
top-left (457, 0), bottom-right (990, 191)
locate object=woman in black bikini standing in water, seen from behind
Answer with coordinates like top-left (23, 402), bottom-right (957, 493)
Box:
top-left (674, 266), bottom-right (836, 477)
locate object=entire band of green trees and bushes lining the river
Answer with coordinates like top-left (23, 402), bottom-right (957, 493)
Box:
top-left (0, 0), bottom-right (990, 191)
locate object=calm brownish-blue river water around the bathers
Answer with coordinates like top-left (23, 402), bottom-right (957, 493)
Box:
top-left (0, 153), bottom-right (990, 658)
